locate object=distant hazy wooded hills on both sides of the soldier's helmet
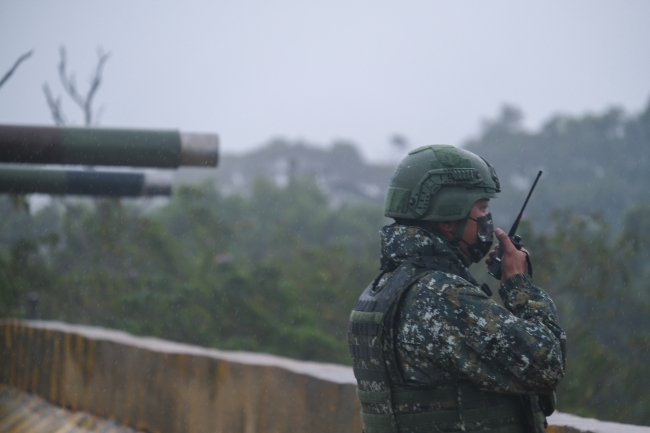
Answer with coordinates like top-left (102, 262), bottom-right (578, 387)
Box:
top-left (176, 95), bottom-right (650, 228)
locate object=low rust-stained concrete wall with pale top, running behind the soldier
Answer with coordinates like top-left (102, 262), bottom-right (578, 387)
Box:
top-left (0, 321), bottom-right (650, 433)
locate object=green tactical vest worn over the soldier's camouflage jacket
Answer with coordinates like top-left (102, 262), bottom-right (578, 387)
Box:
top-left (348, 257), bottom-right (546, 433)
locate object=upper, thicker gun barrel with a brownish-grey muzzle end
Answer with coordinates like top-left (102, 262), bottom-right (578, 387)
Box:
top-left (0, 125), bottom-right (219, 168)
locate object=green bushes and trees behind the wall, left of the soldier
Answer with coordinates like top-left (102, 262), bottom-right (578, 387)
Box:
top-left (0, 178), bottom-right (383, 363)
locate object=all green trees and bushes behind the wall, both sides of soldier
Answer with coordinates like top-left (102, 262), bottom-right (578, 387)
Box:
top-left (0, 98), bottom-right (650, 425)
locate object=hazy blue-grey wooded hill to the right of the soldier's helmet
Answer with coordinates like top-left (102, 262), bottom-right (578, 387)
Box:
top-left (463, 96), bottom-right (650, 226)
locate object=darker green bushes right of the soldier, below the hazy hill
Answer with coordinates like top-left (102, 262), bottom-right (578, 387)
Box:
top-left (520, 213), bottom-right (650, 425)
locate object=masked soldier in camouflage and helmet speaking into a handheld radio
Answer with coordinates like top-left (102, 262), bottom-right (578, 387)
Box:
top-left (349, 145), bottom-right (565, 433)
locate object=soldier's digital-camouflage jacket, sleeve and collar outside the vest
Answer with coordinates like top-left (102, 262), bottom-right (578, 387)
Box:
top-left (378, 224), bottom-right (566, 394)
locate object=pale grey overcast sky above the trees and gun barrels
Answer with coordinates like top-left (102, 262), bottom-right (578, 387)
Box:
top-left (0, 0), bottom-right (650, 160)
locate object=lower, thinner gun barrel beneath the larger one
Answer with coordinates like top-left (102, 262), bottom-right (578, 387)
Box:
top-left (0, 167), bottom-right (172, 197)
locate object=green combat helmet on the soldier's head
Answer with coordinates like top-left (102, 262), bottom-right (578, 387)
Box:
top-left (384, 144), bottom-right (501, 221)
